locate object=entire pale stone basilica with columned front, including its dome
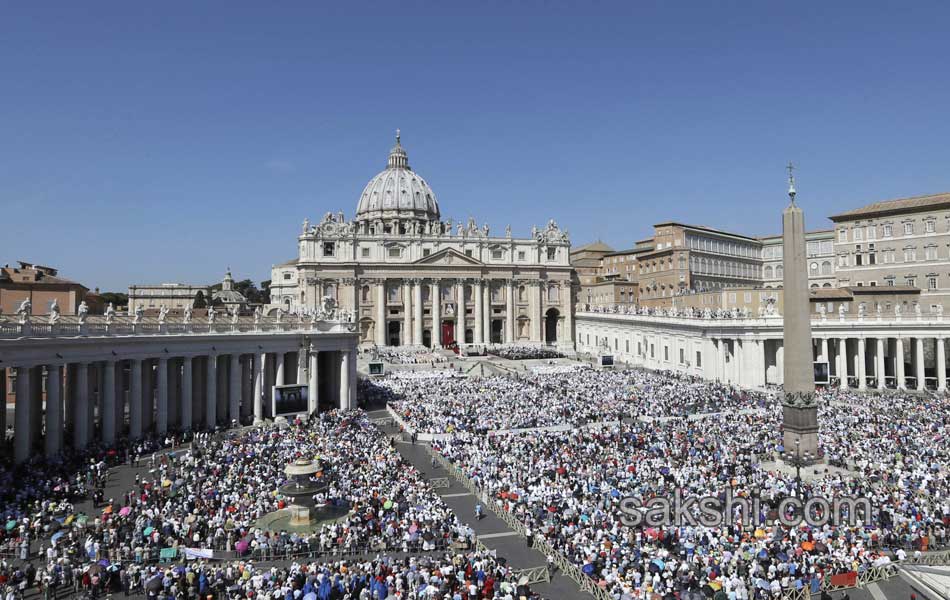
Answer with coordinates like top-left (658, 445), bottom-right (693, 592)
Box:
top-left (271, 133), bottom-right (574, 349)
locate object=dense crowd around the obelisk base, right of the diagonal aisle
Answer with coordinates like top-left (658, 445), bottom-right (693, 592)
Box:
top-left (426, 382), bottom-right (950, 598)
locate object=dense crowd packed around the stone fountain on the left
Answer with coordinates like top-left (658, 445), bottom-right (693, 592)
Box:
top-left (0, 411), bottom-right (556, 598)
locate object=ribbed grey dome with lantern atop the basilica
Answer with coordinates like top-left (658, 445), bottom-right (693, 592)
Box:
top-left (356, 131), bottom-right (439, 221)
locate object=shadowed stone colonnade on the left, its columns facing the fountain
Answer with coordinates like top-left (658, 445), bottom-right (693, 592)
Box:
top-left (0, 317), bottom-right (356, 462)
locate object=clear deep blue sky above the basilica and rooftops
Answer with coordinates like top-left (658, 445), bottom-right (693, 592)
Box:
top-left (0, 1), bottom-right (950, 290)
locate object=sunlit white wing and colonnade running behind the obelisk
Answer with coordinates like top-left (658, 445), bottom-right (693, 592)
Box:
top-left (576, 312), bottom-right (950, 391)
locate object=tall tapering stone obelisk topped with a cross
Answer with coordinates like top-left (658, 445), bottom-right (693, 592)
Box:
top-left (782, 163), bottom-right (818, 460)
